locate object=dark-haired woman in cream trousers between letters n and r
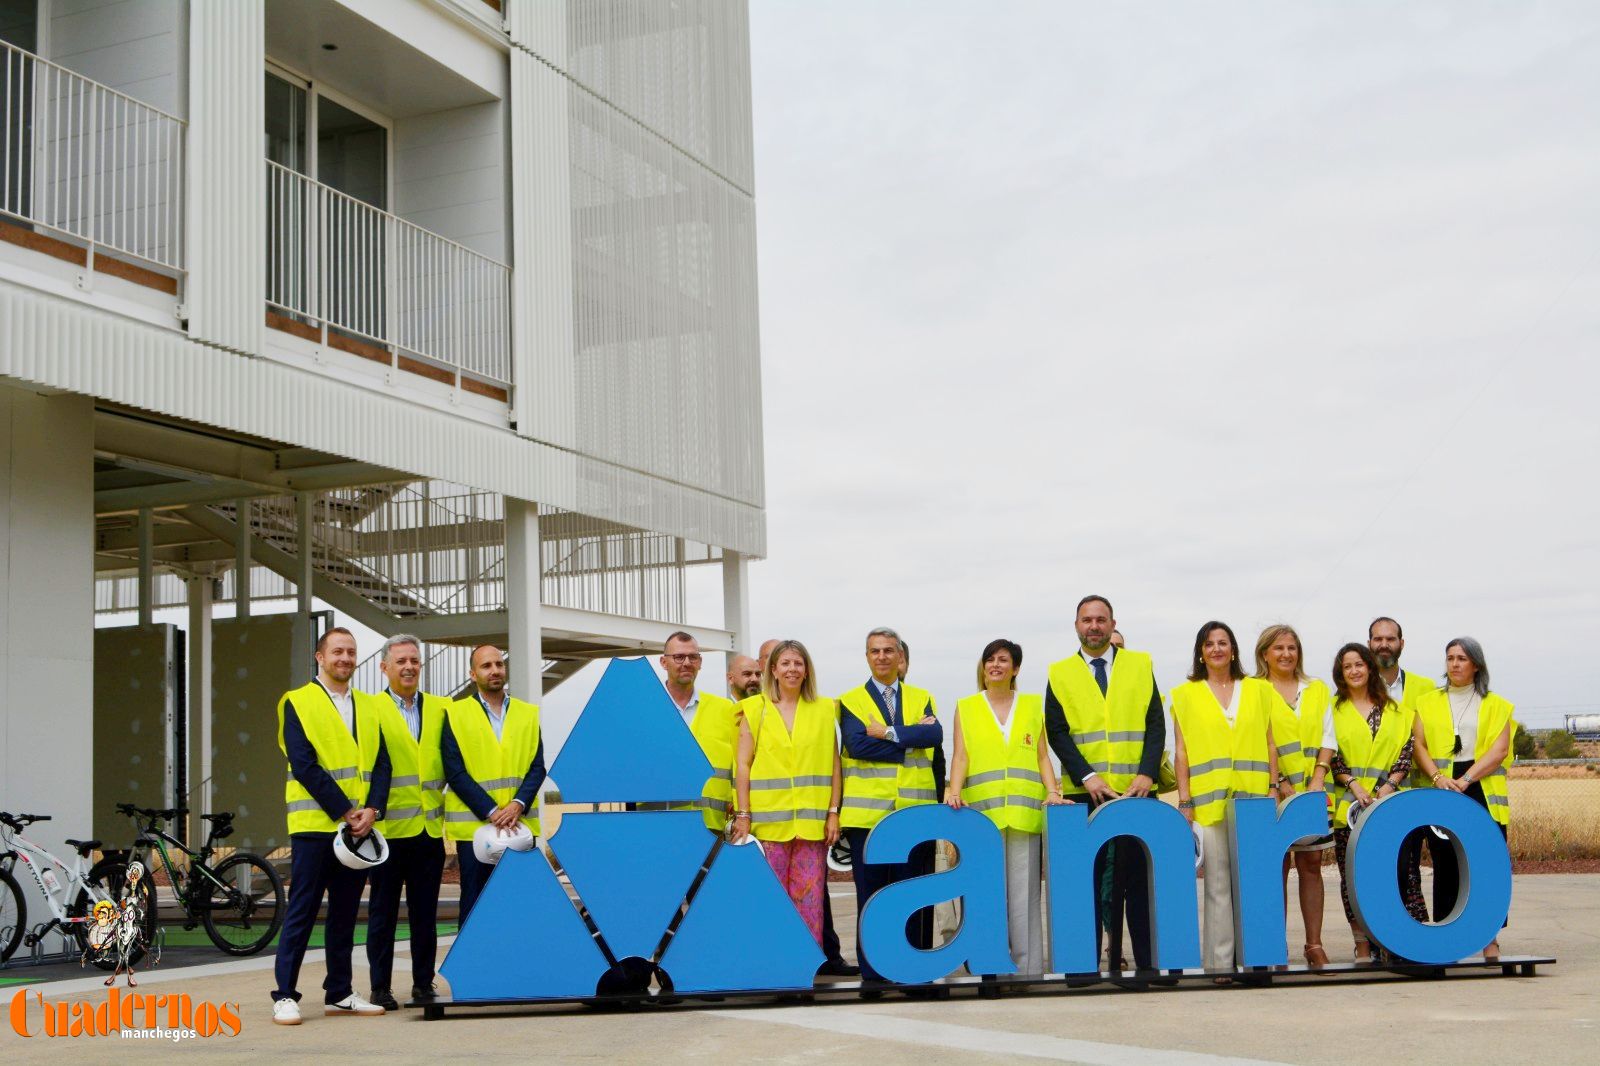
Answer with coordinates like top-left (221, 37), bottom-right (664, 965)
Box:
top-left (1171, 621), bottom-right (1278, 984)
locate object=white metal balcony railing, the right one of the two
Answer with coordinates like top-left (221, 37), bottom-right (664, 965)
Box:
top-left (266, 160), bottom-right (510, 386)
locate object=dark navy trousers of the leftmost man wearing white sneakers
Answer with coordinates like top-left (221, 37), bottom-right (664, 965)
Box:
top-left (272, 834), bottom-right (366, 1004)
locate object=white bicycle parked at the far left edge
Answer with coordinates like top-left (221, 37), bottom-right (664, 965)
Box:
top-left (0, 812), bottom-right (120, 970)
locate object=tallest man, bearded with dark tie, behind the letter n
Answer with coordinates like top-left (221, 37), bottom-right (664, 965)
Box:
top-left (1045, 595), bottom-right (1166, 970)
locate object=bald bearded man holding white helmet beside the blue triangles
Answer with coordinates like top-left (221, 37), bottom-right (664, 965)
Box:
top-left (438, 643), bottom-right (544, 924)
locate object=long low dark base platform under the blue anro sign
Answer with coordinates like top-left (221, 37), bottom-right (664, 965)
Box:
top-left (406, 956), bottom-right (1555, 1021)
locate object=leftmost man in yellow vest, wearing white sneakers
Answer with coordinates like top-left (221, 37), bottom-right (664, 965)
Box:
top-left (272, 626), bottom-right (389, 1026)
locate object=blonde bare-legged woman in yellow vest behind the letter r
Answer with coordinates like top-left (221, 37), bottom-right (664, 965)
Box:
top-left (1256, 626), bottom-right (1339, 970)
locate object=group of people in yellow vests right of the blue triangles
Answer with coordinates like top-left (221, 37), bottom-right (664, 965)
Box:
top-left (713, 595), bottom-right (1517, 994)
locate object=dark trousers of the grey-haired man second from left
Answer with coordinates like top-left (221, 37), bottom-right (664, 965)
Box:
top-left (366, 832), bottom-right (445, 992)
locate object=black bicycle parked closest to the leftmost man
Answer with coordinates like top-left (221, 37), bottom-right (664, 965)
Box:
top-left (109, 804), bottom-right (285, 956)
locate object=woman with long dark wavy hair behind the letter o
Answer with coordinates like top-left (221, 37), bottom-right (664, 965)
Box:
top-left (1331, 643), bottom-right (1427, 962)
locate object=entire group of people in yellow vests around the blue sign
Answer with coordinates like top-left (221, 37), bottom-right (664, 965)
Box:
top-left (272, 595), bottom-right (1517, 1024)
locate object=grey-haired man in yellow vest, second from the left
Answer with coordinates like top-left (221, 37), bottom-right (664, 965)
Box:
top-left (366, 632), bottom-right (448, 1010)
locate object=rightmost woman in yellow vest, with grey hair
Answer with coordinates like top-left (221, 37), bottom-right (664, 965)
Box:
top-left (1411, 637), bottom-right (1517, 960)
